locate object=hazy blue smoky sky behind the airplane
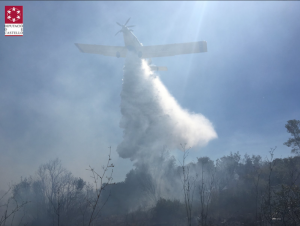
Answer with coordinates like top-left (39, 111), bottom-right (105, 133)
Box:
top-left (0, 1), bottom-right (300, 192)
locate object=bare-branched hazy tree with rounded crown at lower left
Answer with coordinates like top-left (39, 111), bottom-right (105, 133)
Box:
top-left (12, 159), bottom-right (88, 226)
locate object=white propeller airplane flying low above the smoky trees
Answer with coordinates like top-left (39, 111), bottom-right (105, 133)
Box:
top-left (75, 18), bottom-right (207, 71)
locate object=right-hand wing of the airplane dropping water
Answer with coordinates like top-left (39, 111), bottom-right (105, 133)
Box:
top-left (140, 41), bottom-right (207, 58)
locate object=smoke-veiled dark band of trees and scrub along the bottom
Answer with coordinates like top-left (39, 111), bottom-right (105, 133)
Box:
top-left (0, 120), bottom-right (300, 226)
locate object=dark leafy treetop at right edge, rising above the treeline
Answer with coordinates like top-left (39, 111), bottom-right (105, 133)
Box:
top-left (283, 119), bottom-right (300, 155)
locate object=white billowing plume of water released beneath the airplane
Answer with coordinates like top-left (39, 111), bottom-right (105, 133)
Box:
top-left (117, 53), bottom-right (217, 163)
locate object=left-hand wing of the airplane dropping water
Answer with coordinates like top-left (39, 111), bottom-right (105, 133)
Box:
top-left (75, 43), bottom-right (127, 57)
